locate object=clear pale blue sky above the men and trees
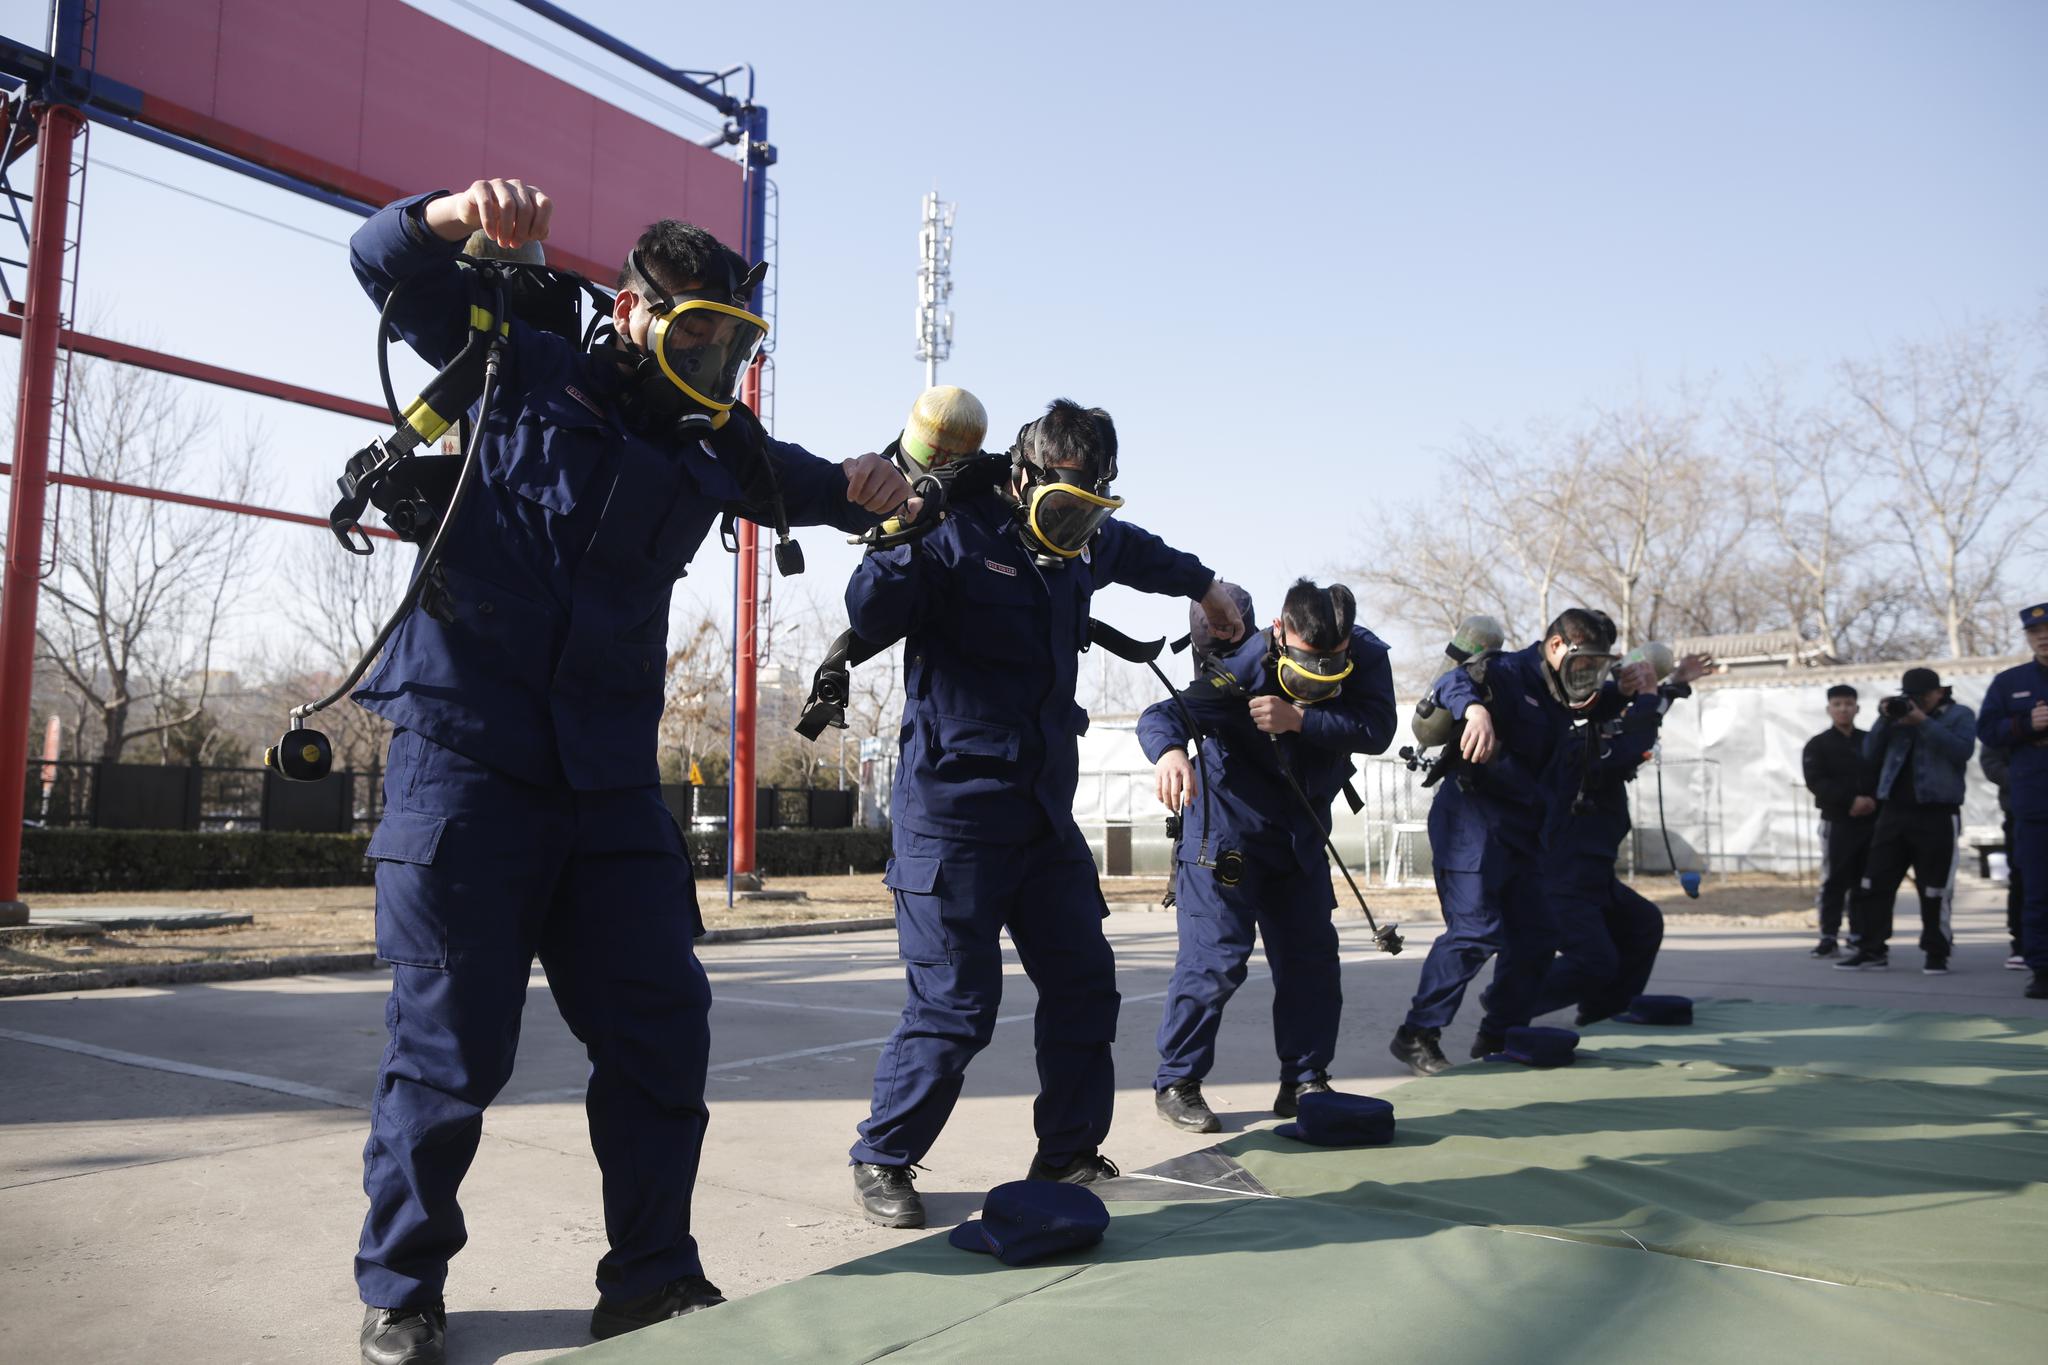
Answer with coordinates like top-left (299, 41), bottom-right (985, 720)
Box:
top-left (0, 0), bottom-right (2048, 671)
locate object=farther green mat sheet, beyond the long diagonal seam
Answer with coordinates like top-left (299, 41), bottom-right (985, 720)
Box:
top-left (1225, 1001), bottom-right (2048, 1326)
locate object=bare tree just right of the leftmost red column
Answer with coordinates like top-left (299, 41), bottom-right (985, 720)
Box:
top-left (37, 358), bottom-right (256, 761)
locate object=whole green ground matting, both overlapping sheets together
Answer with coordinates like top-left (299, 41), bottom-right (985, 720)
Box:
top-left (561, 1001), bottom-right (2048, 1365)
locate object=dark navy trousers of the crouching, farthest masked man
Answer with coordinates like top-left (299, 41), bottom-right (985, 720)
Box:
top-left (1534, 860), bottom-right (1663, 1023)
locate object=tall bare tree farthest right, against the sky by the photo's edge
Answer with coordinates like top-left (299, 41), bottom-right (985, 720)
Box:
top-left (1839, 325), bottom-right (2048, 659)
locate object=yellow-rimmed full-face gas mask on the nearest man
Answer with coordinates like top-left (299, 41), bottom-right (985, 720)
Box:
top-left (618, 250), bottom-right (768, 436)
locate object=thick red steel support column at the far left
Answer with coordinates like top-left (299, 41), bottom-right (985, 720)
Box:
top-left (0, 104), bottom-right (84, 925)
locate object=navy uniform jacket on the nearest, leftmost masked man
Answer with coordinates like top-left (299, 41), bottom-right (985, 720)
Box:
top-left (350, 194), bottom-right (874, 790)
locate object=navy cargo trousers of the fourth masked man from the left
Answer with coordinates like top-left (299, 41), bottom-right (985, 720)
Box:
top-left (1407, 845), bottom-right (1556, 1033)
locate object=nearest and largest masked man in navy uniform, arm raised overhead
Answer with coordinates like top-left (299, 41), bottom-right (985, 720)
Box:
top-left (350, 180), bottom-right (909, 1365)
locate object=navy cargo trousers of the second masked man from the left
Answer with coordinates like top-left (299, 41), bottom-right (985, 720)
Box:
top-left (852, 823), bottom-right (1118, 1166)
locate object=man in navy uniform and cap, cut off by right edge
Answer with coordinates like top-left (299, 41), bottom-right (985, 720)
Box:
top-left (1976, 602), bottom-right (2048, 1001)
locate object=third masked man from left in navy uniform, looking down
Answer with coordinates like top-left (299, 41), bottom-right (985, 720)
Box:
top-left (1139, 579), bottom-right (1397, 1132)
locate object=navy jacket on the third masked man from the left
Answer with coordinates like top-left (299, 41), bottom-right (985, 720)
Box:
top-left (1139, 626), bottom-right (1399, 872)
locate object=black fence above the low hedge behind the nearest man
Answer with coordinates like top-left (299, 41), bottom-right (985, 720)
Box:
top-left (23, 759), bottom-right (860, 835)
